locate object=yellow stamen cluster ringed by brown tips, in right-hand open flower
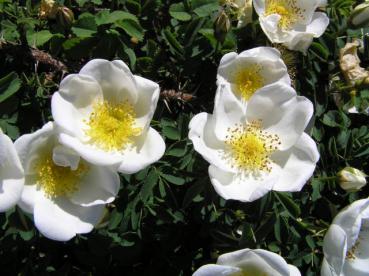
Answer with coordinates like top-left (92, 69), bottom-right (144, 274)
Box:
top-left (226, 121), bottom-right (281, 174)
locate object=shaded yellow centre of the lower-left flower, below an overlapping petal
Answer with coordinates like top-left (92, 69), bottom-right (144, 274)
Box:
top-left (37, 154), bottom-right (89, 198)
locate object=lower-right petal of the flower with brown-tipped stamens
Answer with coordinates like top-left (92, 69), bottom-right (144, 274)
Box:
top-left (272, 133), bottom-right (319, 192)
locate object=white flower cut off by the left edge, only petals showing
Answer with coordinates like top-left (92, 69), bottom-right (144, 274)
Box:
top-left (0, 128), bottom-right (24, 212)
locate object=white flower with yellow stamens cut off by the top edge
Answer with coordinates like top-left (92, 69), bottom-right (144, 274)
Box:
top-left (253, 0), bottom-right (329, 52)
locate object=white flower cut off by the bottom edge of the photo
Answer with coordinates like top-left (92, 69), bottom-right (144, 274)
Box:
top-left (193, 248), bottom-right (301, 276)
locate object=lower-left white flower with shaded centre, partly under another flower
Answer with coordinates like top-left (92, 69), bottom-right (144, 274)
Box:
top-left (15, 122), bottom-right (120, 241)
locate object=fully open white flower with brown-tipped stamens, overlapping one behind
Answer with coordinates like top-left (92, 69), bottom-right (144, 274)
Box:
top-left (189, 82), bottom-right (319, 201)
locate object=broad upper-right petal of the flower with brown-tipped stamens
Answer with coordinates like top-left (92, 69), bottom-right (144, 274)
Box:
top-left (246, 83), bottom-right (313, 150)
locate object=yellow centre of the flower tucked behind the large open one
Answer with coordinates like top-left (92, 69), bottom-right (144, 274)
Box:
top-left (236, 65), bottom-right (264, 101)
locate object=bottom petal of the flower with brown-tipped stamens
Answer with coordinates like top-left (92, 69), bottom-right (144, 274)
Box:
top-left (209, 165), bottom-right (278, 202)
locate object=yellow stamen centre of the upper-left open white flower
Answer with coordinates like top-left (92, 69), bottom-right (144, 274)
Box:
top-left (85, 101), bottom-right (141, 151)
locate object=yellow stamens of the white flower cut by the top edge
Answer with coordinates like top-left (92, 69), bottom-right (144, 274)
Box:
top-left (265, 0), bottom-right (305, 29)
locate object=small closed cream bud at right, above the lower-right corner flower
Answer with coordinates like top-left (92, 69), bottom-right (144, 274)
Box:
top-left (337, 167), bottom-right (367, 192)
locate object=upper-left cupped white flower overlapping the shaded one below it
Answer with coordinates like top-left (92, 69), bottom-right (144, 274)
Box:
top-left (52, 59), bottom-right (165, 174)
